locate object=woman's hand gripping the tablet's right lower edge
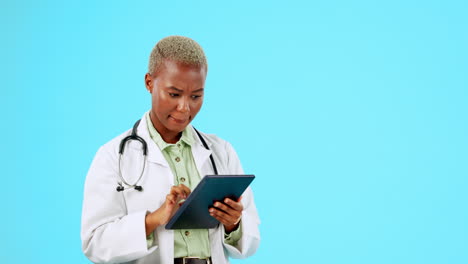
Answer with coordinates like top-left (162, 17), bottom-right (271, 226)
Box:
top-left (209, 197), bottom-right (244, 233)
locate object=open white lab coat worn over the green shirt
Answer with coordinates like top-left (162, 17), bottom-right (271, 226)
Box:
top-left (81, 113), bottom-right (260, 264)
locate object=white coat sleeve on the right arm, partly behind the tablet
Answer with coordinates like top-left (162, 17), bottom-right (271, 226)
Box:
top-left (221, 142), bottom-right (260, 258)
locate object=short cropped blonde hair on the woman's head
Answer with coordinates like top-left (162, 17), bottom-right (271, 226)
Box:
top-left (148, 36), bottom-right (208, 74)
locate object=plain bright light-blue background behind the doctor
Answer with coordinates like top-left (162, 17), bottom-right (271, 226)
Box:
top-left (0, 0), bottom-right (468, 264)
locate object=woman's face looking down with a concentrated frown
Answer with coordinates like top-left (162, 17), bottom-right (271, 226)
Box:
top-left (145, 60), bottom-right (206, 143)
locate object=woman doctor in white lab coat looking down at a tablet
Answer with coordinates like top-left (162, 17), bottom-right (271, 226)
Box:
top-left (81, 36), bottom-right (260, 264)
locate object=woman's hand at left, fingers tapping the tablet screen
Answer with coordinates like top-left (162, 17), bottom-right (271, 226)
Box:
top-left (145, 184), bottom-right (191, 236)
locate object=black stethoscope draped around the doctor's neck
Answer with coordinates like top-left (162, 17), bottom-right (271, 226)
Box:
top-left (116, 119), bottom-right (218, 192)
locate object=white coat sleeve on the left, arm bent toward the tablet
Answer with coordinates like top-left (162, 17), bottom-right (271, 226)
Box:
top-left (81, 146), bottom-right (157, 263)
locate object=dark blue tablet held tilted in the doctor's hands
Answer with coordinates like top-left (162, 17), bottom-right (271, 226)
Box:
top-left (166, 175), bottom-right (255, 229)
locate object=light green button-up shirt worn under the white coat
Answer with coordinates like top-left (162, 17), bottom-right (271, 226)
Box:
top-left (146, 113), bottom-right (241, 258)
